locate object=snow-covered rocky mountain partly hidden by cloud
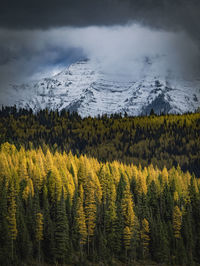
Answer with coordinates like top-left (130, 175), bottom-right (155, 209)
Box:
top-left (3, 57), bottom-right (200, 116)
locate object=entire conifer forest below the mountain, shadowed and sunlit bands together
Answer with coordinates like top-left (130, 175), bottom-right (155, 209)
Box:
top-left (0, 107), bottom-right (200, 266)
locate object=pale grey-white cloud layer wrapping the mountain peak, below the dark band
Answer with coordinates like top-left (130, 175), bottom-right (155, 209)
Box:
top-left (0, 24), bottom-right (200, 90)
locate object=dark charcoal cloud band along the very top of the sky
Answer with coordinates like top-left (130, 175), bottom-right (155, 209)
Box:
top-left (0, 0), bottom-right (200, 31)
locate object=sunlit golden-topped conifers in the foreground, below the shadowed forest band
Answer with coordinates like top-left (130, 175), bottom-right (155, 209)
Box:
top-left (0, 143), bottom-right (200, 265)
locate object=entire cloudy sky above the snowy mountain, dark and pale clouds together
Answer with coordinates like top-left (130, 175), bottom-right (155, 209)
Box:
top-left (0, 0), bottom-right (200, 92)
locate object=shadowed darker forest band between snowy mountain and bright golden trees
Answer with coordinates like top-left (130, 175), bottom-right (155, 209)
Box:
top-left (0, 107), bottom-right (200, 177)
